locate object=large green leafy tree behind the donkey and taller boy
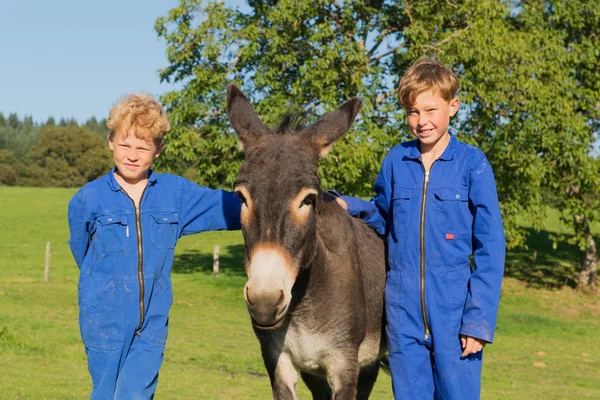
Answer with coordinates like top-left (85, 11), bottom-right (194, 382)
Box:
top-left (156, 0), bottom-right (598, 290)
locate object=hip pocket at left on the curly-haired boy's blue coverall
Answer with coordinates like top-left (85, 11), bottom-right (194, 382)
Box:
top-left (79, 280), bottom-right (123, 350)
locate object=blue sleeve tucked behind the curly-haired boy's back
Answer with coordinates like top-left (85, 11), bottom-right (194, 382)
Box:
top-left (68, 191), bottom-right (90, 269)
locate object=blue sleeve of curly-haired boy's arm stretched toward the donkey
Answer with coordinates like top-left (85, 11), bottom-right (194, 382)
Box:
top-left (180, 178), bottom-right (241, 235)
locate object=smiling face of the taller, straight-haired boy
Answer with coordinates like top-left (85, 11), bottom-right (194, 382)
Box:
top-left (406, 90), bottom-right (460, 147)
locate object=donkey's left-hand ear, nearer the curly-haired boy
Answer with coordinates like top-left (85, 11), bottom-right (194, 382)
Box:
top-left (227, 84), bottom-right (268, 150)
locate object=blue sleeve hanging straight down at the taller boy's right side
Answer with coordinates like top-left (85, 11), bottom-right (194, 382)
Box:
top-left (460, 157), bottom-right (505, 343)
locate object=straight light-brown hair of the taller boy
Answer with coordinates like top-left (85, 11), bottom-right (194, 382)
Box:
top-left (398, 59), bottom-right (458, 110)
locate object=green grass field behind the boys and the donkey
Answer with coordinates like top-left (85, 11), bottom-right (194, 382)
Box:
top-left (0, 187), bottom-right (600, 400)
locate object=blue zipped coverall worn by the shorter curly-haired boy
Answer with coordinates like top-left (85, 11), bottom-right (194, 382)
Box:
top-left (69, 169), bottom-right (240, 400)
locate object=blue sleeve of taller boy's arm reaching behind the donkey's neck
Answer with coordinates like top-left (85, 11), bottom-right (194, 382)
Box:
top-left (342, 154), bottom-right (392, 235)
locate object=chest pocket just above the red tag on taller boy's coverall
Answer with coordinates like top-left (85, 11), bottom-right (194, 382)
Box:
top-left (434, 187), bottom-right (473, 234)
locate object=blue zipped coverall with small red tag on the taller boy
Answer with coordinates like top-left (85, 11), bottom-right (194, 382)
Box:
top-left (343, 135), bottom-right (505, 400)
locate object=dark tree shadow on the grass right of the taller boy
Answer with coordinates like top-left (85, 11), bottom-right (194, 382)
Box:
top-left (504, 229), bottom-right (600, 289)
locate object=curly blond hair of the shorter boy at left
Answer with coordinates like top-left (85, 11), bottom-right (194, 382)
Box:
top-left (106, 93), bottom-right (171, 144)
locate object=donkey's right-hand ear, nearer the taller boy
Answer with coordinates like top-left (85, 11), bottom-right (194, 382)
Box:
top-left (305, 97), bottom-right (362, 157)
